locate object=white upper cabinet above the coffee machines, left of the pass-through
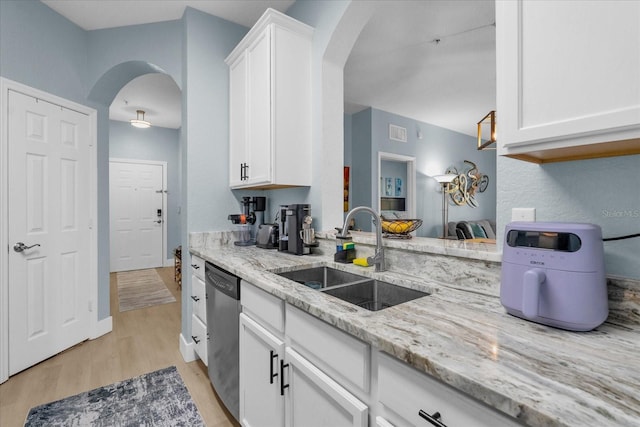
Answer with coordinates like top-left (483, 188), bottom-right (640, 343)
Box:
top-left (226, 9), bottom-right (313, 188)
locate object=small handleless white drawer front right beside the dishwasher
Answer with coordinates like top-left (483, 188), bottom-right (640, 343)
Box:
top-left (240, 280), bottom-right (284, 334)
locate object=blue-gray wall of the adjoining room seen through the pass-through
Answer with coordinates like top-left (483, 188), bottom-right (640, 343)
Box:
top-left (351, 108), bottom-right (496, 237)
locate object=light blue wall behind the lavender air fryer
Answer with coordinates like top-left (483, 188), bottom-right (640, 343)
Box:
top-left (497, 155), bottom-right (640, 279)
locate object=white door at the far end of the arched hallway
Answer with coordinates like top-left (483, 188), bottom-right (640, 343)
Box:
top-left (109, 160), bottom-right (164, 271)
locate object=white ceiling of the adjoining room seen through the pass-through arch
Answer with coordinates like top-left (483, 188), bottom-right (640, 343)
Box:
top-left (344, 0), bottom-right (496, 136)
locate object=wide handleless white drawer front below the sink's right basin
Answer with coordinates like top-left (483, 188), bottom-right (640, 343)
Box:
top-left (286, 305), bottom-right (371, 393)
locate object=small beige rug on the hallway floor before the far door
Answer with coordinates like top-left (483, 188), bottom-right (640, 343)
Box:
top-left (116, 268), bottom-right (176, 312)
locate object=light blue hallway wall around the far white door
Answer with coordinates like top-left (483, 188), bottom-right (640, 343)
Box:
top-left (109, 120), bottom-right (181, 259)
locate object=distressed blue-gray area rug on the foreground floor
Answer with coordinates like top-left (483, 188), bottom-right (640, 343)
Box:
top-left (25, 366), bottom-right (204, 427)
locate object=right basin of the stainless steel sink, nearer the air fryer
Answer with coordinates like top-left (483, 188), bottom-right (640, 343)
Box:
top-left (322, 279), bottom-right (429, 311)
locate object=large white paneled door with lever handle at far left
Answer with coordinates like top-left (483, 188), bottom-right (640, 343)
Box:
top-left (8, 90), bottom-right (92, 375)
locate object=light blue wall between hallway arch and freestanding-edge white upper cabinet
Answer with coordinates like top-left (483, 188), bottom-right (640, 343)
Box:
top-left (181, 8), bottom-right (248, 337)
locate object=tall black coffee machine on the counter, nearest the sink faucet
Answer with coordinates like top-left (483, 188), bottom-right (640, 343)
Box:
top-left (280, 204), bottom-right (318, 255)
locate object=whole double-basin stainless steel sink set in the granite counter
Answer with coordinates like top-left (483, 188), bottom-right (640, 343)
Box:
top-left (277, 267), bottom-right (429, 311)
